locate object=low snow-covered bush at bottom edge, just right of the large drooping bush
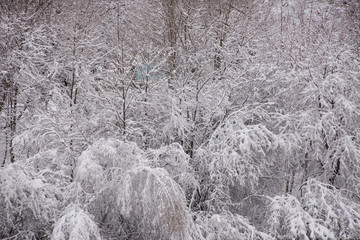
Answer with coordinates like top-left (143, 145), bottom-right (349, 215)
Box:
top-left (195, 213), bottom-right (273, 240)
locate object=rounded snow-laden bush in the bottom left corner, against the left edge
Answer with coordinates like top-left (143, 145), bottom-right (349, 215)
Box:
top-left (0, 162), bottom-right (61, 239)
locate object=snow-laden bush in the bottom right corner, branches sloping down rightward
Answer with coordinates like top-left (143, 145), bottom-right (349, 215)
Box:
top-left (302, 179), bottom-right (360, 239)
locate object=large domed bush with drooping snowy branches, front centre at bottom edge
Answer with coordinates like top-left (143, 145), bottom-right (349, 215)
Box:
top-left (118, 167), bottom-right (196, 240)
